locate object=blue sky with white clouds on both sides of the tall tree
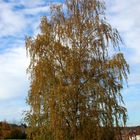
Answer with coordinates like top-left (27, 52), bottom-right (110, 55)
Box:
top-left (0, 0), bottom-right (140, 125)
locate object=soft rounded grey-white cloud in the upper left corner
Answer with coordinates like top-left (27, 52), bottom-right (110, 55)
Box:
top-left (0, 2), bottom-right (26, 37)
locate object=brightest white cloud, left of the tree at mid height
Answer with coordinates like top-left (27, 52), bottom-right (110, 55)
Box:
top-left (0, 47), bottom-right (28, 100)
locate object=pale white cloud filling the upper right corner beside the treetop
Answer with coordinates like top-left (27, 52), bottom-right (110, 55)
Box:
top-left (107, 0), bottom-right (140, 64)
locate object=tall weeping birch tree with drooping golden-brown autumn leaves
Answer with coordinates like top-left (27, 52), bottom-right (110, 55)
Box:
top-left (25, 0), bottom-right (129, 140)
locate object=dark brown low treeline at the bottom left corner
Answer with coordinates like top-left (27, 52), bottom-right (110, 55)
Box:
top-left (0, 121), bottom-right (26, 139)
